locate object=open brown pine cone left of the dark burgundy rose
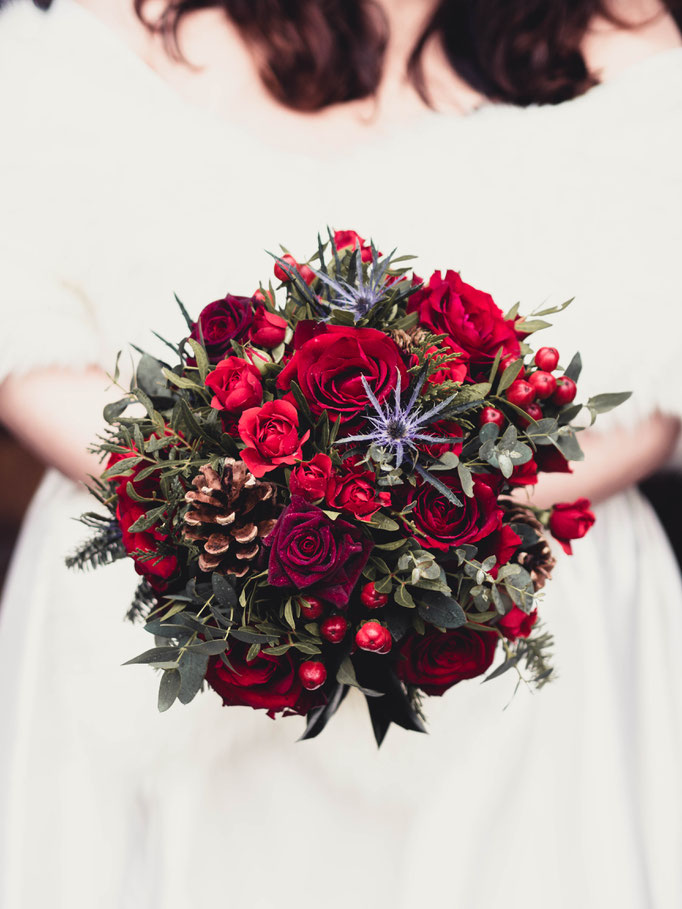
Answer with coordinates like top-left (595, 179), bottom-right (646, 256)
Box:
top-left (185, 458), bottom-right (281, 577)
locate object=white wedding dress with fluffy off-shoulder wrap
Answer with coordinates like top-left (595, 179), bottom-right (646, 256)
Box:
top-left (0, 0), bottom-right (682, 909)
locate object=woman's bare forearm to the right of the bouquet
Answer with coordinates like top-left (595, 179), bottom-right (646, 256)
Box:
top-left (519, 414), bottom-right (680, 508)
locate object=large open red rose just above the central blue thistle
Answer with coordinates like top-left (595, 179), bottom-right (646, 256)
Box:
top-left (277, 322), bottom-right (409, 421)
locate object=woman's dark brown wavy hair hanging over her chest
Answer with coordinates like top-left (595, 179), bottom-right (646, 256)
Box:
top-left (23, 0), bottom-right (682, 111)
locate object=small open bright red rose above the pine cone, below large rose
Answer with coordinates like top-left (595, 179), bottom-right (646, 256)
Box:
top-left (238, 401), bottom-right (310, 477)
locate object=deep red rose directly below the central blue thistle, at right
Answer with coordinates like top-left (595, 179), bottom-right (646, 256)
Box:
top-left (407, 473), bottom-right (503, 551)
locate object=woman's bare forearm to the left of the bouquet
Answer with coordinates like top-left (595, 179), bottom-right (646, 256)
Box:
top-left (0, 367), bottom-right (122, 482)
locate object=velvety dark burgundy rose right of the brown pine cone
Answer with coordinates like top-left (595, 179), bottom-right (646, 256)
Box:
top-left (266, 496), bottom-right (373, 607)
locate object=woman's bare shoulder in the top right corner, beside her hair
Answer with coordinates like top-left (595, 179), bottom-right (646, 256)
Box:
top-left (583, 0), bottom-right (682, 82)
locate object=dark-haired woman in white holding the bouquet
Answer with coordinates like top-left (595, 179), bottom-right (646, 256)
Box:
top-left (0, 0), bottom-right (682, 909)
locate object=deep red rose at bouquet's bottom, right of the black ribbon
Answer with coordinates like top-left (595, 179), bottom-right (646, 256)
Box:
top-left (395, 628), bottom-right (498, 695)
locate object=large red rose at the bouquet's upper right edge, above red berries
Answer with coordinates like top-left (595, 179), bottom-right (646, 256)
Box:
top-left (407, 271), bottom-right (521, 381)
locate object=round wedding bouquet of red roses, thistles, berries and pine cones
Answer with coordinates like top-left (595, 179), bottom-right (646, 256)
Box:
top-left (69, 231), bottom-right (627, 743)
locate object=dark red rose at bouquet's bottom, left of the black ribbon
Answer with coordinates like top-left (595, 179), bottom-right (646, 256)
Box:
top-left (206, 641), bottom-right (323, 717)
